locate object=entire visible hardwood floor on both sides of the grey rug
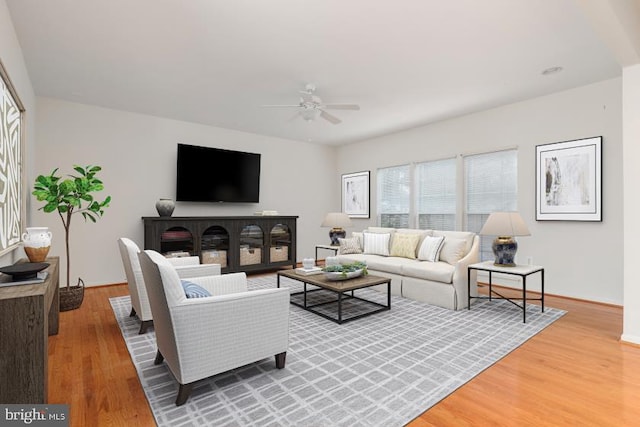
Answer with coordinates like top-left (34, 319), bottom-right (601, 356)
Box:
top-left (49, 285), bottom-right (640, 427)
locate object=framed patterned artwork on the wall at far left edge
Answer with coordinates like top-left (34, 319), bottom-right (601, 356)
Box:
top-left (0, 62), bottom-right (25, 256)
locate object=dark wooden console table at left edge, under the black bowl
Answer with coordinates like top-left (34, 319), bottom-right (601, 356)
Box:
top-left (0, 257), bottom-right (60, 404)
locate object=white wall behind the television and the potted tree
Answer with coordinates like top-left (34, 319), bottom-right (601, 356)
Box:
top-left (30, 98), bottom-right (340, 285)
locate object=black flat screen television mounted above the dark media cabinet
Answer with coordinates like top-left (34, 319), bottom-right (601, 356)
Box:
top-left (176, 144), bottom-right (260, 203)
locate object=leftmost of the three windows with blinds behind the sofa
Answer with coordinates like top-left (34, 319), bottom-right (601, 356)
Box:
top-left (377, 165), bottom-right (411, 228)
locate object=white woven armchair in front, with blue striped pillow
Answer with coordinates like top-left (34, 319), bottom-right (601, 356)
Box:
top-left (139, 250), bottom-right (289, 406)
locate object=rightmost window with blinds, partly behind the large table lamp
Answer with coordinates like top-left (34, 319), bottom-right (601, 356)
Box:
top-left (464, 150), bottom-right (518, 261)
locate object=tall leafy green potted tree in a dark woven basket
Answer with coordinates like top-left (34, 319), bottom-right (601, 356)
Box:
top-left (32, 165), bottom-right (111, 311)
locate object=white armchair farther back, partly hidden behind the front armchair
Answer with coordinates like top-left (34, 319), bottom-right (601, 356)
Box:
top-left (118, 237), bottom-right (220, 334)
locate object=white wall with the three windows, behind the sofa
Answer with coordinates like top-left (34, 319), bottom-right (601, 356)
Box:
top-left (336, 79), bottom-right (624, 304)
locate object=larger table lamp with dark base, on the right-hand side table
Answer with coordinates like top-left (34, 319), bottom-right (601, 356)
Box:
top-left (480, 212), bottom-right (531, 267)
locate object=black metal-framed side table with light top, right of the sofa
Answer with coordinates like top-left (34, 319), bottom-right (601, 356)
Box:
top-left (467, 261), bottom-right (544, 323)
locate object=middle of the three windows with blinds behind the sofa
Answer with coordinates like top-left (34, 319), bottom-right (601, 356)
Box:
top-left (415, 158), bottom-right (457, 230)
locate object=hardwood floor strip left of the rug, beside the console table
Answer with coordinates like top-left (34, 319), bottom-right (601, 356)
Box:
top-left (49, 285), bottom-right (155, 426)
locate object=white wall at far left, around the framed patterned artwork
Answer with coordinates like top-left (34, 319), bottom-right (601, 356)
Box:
top-left (0, 0), bottom-right (36, 265)
